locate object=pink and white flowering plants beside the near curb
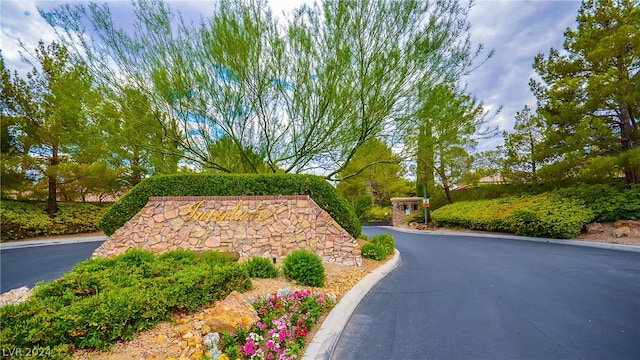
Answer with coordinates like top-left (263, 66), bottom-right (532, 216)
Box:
top-left (220, 289), bottom-right (336, 360)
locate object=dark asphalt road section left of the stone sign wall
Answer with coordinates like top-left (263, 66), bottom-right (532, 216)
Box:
top-left (0, 240), bottom-right (103, 293)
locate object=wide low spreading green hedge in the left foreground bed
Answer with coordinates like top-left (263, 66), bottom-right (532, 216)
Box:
top-left (0, 249), bottom-right (251, 358)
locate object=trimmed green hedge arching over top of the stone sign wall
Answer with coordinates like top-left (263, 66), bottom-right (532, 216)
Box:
top-left (99, 174), bottom-right (362, 238)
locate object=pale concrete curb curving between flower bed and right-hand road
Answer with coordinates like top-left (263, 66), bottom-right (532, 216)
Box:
top-left (302, 250), bottom-right (402, 360)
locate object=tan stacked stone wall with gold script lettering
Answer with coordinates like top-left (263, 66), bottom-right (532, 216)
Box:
top-left (94, 195), bottom-right (362, 266)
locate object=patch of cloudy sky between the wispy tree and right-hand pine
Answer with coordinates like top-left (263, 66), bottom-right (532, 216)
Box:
top-left (465, 0), bottom-right (580, 150)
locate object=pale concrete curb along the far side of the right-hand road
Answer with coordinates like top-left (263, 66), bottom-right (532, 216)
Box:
top-left (380, 226), bottom-right (640, 253)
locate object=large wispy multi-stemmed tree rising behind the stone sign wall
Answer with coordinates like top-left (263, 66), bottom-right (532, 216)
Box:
top-left (41, 0), bottom-right (488, 180)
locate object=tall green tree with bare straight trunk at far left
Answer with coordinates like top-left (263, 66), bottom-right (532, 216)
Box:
top-left (3, 41), bottom-right (99, 216)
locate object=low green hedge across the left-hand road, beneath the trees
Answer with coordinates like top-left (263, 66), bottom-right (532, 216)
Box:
top-left (0, 200), bottom-right (111, 241)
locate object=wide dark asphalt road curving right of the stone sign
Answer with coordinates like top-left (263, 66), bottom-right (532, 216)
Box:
top-left (332, 228), bottom-right (640, 360)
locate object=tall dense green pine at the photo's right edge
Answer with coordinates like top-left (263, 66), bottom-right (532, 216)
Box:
top-left (530, 0), bottom-right (640, 184)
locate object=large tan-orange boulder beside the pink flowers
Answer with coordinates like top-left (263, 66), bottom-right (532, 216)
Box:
top-left (204, 291), bottom-right (260, 333)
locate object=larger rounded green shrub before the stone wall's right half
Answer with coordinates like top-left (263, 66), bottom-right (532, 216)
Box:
top-left (282, 249), bottom-right (326, 287)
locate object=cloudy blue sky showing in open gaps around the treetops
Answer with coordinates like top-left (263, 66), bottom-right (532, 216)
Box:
top-left (0, 0), bottom-right (580, 150)
